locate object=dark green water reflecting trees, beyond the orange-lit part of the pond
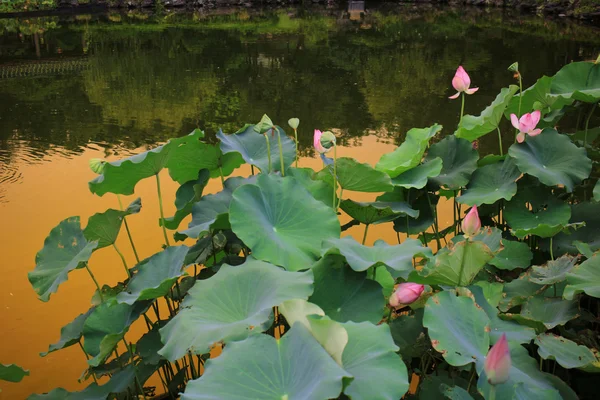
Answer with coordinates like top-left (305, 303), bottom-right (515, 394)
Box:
top-left (0, 6), bottom-right (600, 162)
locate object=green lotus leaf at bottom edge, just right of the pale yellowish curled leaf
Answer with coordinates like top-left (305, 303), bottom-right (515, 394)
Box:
top-left (342, 322), bottom-right (409, 400)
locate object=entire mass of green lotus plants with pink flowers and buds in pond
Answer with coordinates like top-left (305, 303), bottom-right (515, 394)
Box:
top-left (22, 62), bottom-right (600, 400)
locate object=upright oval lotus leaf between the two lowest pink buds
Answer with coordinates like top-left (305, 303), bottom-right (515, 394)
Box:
top-left (423, 292), bottom-right (490, 367)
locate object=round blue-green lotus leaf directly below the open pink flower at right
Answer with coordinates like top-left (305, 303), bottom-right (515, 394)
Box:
top-left (508, 129), bottom-right (592, 192)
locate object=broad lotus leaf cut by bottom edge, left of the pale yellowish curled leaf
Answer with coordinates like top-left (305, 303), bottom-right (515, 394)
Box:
top-left (181, 323), bottom-right (351, 400)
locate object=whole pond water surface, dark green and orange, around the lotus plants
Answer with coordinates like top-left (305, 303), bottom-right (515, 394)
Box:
top-left (0, 2), bottom-right (600, 399)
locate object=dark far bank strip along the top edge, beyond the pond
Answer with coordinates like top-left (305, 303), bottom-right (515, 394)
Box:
top-left (0, 0), bottom-right (600, 21)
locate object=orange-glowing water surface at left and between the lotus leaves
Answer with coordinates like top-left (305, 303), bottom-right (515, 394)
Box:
top-left (0, 136), bottom-right (452, 399)
